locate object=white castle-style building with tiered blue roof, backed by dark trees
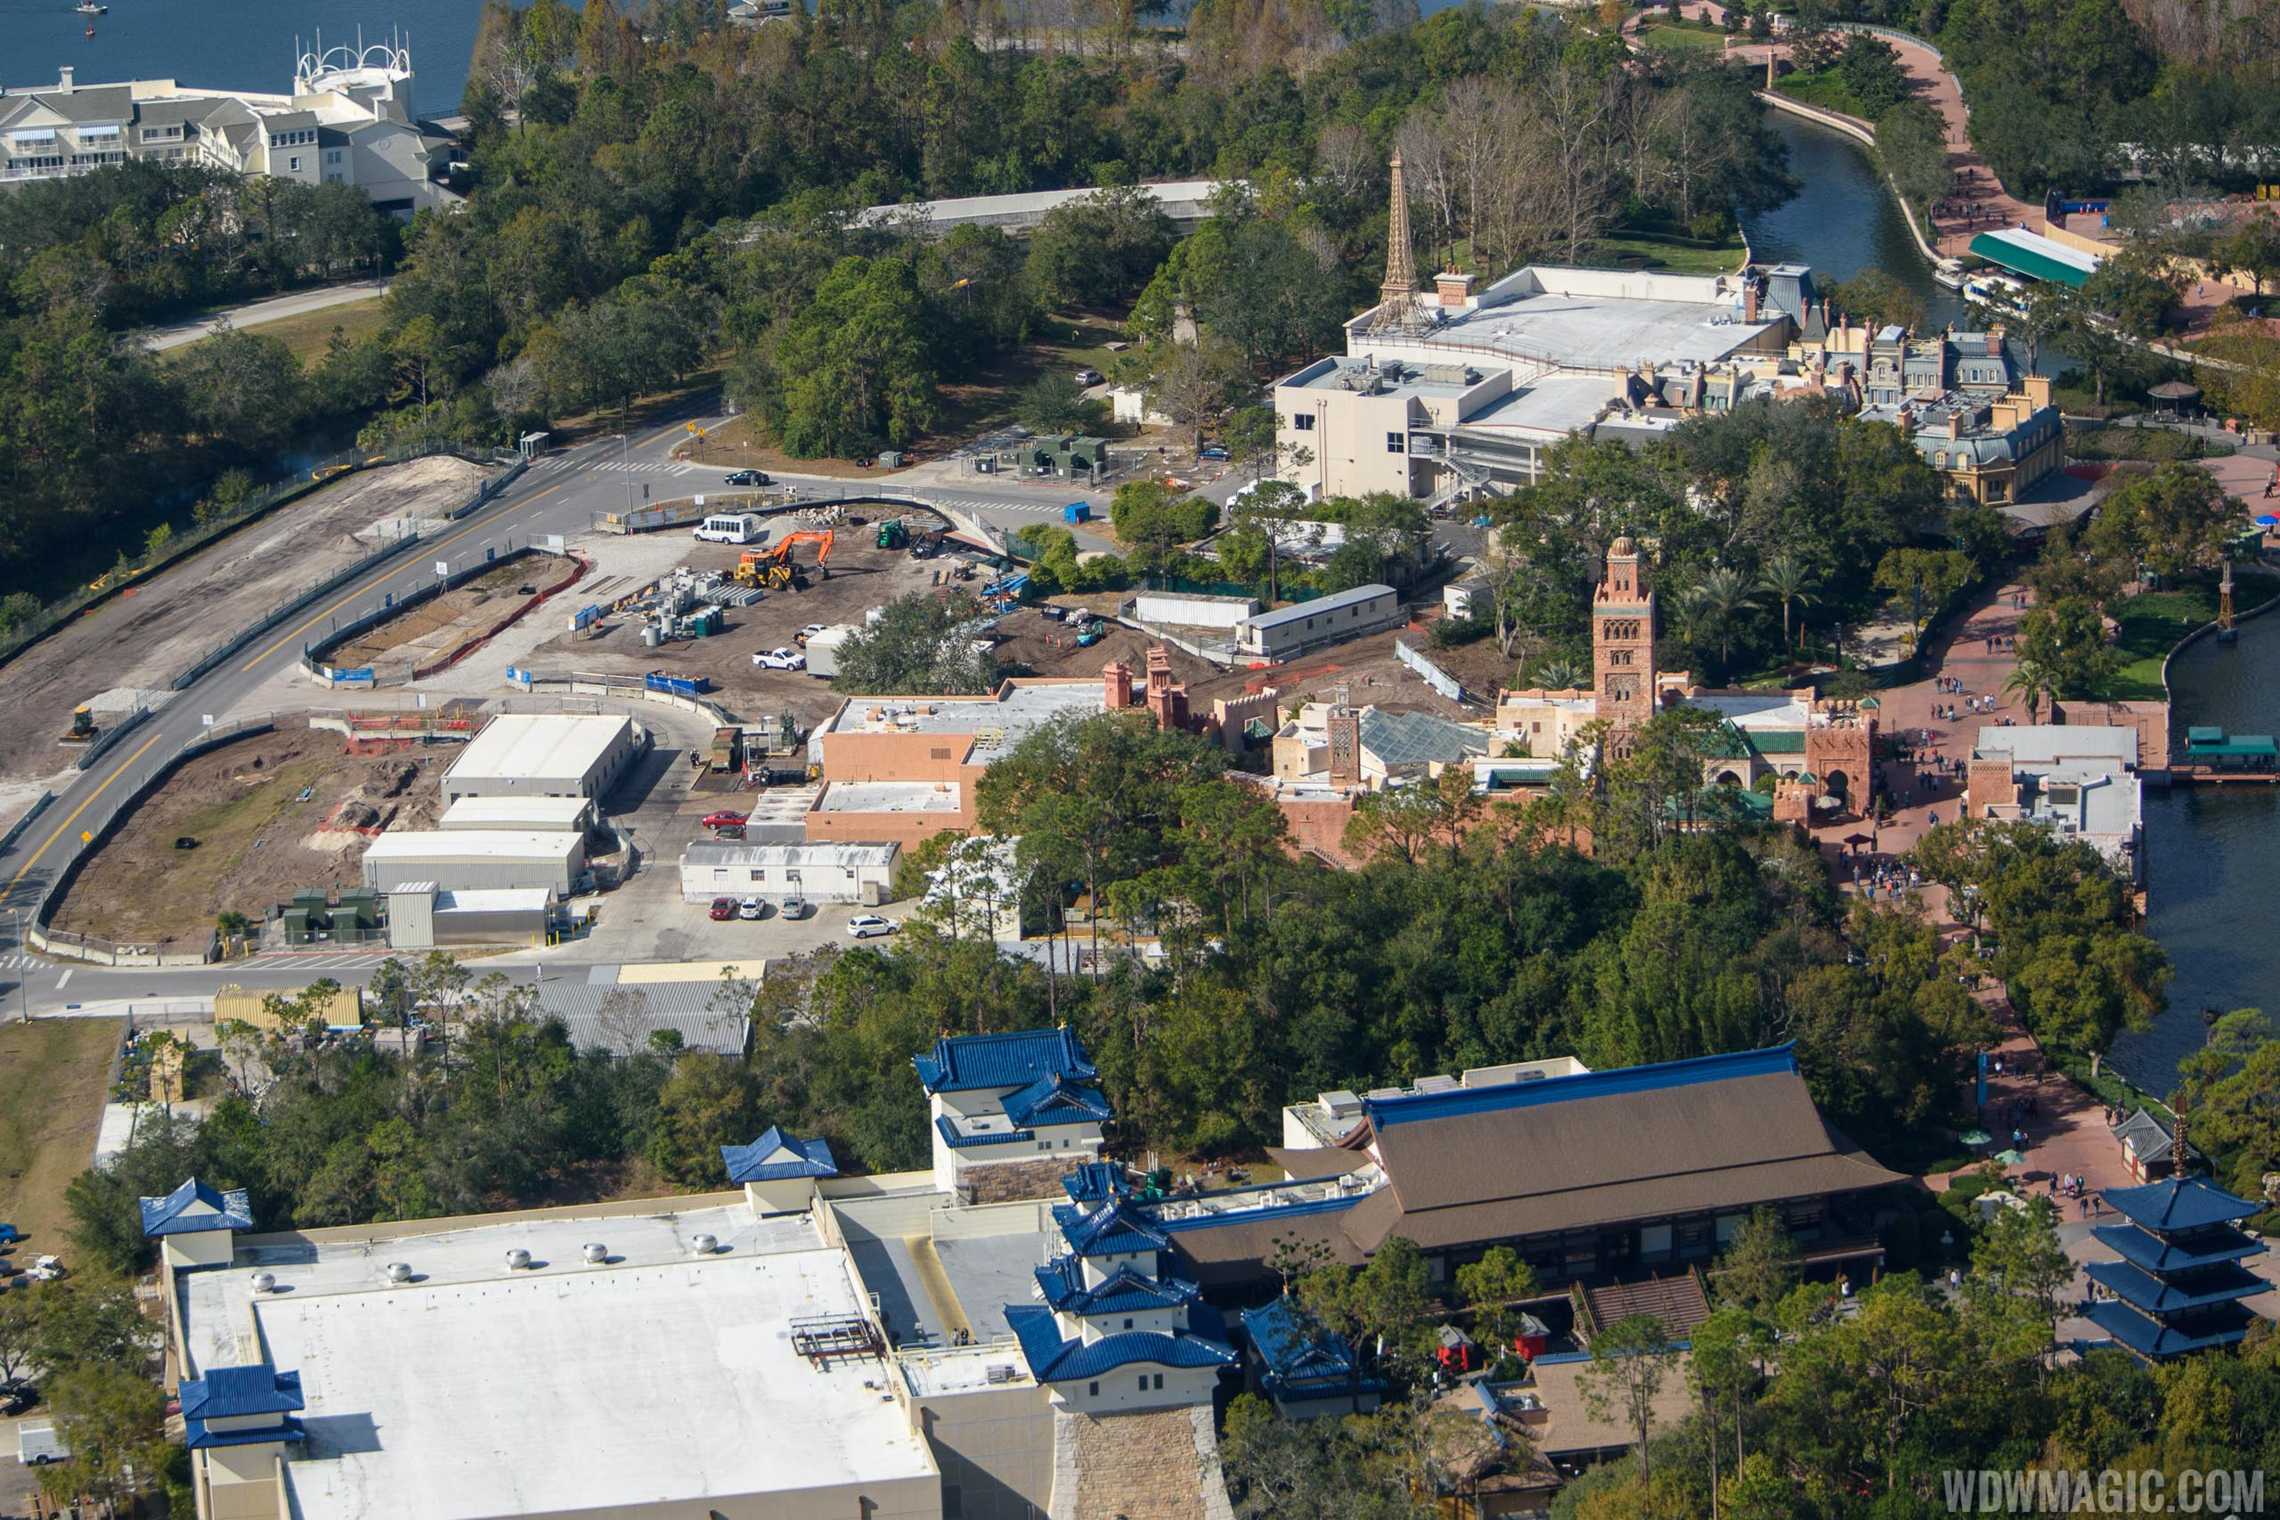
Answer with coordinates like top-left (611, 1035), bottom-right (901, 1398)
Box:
top-left (910, 1028), bottom-right (1115, 1203)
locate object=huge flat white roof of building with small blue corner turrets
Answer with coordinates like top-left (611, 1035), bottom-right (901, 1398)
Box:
top-left (176, 1201), bottom-right (937, 1520)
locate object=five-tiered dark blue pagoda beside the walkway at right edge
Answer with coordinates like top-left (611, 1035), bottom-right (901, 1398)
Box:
top-left (2084, 1176), bottom-right (2266, 1360)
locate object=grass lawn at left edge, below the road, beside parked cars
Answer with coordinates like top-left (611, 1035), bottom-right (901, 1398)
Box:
top-left (0, 1019), bottom-right (123, 1260)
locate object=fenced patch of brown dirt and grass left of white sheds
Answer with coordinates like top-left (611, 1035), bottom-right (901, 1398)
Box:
top-left (57, 729), bottom-right (456, 943)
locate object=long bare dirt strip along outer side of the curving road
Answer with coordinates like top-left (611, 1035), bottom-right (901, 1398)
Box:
top-left (0, 458), bottom-right (483, 820)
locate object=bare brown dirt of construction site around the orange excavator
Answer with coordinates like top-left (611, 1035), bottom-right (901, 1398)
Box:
top-left (529, 520), bottom-right (953, 727)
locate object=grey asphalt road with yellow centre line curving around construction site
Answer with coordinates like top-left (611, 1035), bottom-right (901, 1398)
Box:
top-left (0, 408), bottom-right (1140, 1019)
